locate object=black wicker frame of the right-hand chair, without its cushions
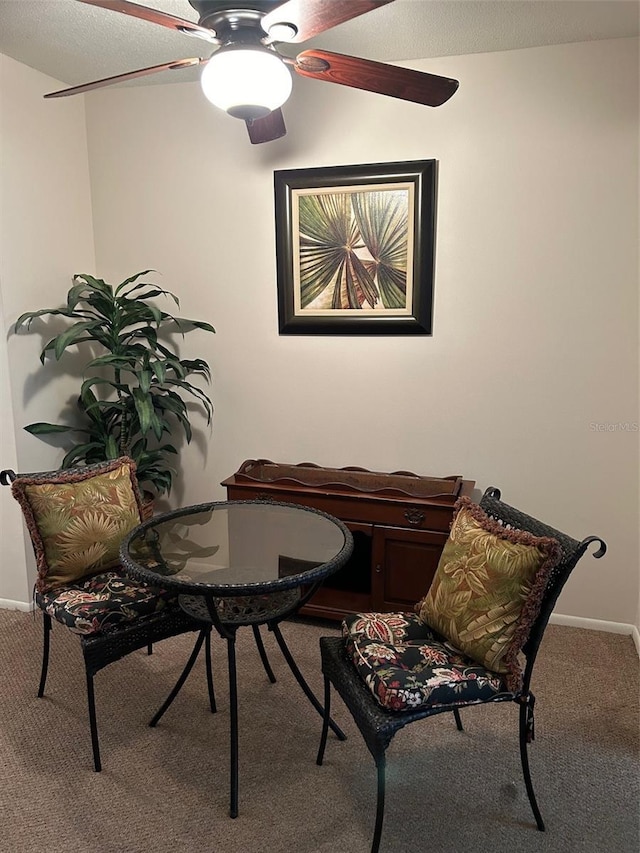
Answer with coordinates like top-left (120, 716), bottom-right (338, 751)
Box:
top-left (317, 487), bottom-right (606, 853)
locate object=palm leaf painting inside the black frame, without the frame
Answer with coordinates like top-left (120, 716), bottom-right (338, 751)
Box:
top-left (298, 188), bottom-right (409, 310)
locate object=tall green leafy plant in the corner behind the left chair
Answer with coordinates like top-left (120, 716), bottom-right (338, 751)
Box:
top-left (14, 270), bottom-right (215, 495)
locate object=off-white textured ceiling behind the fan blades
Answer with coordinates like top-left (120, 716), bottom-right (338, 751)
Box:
top-left (0, 0), bottom-right (640, 91)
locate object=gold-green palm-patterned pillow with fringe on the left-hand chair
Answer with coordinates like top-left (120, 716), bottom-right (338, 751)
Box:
top-left (11, 457), bottom-right (141, 592)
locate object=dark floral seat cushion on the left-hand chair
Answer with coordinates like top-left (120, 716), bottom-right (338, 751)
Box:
top-left (35, 570), bottom-right (177, 635)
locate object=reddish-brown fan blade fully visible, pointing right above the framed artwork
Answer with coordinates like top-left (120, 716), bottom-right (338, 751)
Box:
top-left (293, 50), bottom-right (459, 107)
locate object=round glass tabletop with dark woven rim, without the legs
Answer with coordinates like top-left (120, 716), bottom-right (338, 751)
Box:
top-left (122, 501), bottom-right (353, 597)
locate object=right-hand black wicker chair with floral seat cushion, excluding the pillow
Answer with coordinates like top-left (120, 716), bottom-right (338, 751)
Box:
top-left (317, 488), bottom-right (606, 853)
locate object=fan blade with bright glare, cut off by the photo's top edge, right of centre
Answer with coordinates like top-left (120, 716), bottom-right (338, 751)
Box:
top-left (262, 0), bottom-right (393, 43)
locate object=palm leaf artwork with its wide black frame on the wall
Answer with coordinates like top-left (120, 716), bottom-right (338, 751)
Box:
top-left (274, 160), bottom-right (436, 335)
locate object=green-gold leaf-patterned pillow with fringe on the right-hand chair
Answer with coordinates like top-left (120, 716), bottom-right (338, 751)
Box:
top-left (416, 497), bottom-right (560, 690)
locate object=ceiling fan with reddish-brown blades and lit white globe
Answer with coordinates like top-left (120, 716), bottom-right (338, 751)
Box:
top-left (45, 0), bottom-right (458, 143)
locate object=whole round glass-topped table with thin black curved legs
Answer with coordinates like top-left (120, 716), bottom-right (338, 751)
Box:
top-left (120, 501), bottom-right (353, 817)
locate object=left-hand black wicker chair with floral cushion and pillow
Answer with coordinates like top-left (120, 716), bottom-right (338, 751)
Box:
top-left (0, 457), bottom-right (216, 771)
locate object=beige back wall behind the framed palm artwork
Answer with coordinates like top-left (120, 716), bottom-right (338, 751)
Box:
top-left (5, 40), bottom-right (640, 623)
